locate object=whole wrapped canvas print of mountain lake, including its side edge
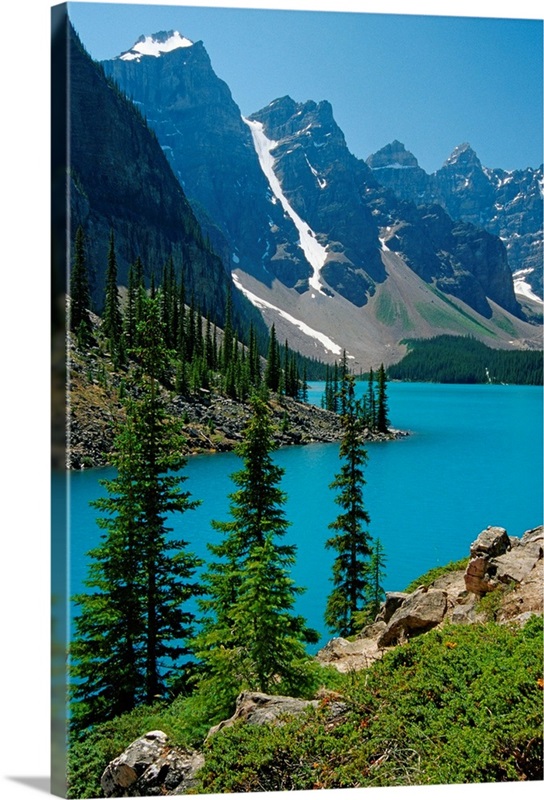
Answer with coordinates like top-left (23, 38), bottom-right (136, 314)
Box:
top-left (52, 3), bottom-right (544, 798)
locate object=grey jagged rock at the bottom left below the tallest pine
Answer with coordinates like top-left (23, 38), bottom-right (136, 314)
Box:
top-left (100, 731), bottom-right (204, 797)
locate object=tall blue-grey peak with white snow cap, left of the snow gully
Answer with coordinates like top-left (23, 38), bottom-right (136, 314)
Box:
top-left (102, 31), bottom-right (311, 290)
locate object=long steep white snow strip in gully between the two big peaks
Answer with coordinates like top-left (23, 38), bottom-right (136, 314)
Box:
top-left (242, 117), bottom-right (330, 296)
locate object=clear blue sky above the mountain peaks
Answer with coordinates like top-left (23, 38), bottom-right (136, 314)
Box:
top-left (69, 3), bottom-right (543, 171)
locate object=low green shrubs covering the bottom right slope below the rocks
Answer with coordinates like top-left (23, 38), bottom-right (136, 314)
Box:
top-left (200, 617), bottom-right (542, 793)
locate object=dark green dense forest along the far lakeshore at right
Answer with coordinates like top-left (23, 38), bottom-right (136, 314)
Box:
top-left (388, 335), bottom-right (542, 386)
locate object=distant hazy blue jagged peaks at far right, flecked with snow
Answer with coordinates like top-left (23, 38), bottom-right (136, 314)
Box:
top-left (366, 141), bottom-right (544, 298)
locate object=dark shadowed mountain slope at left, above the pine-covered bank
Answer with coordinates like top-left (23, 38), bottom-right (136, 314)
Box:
top-left (63, 25), bottom-right (255, 334)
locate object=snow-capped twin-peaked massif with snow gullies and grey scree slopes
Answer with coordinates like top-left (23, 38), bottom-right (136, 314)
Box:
top-left (103, 31), bottom-right (538, 369)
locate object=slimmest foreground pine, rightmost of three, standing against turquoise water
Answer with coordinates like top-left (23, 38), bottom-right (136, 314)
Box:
top-left (325, 375), bottom-right (372, 636)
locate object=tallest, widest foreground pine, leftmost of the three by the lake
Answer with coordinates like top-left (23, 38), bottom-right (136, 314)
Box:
top-left (71, 298), bottom-right (201, 729)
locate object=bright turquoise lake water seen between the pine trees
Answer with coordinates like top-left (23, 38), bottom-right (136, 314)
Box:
top-left (69, 383), bottom-right (543, 649)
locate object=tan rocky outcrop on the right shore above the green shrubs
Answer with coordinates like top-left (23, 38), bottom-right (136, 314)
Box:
top-left (316, 526), bottom-right (544, 672)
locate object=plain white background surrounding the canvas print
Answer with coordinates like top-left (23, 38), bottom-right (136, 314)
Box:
top-left (0, 0), bottom-right (543, 800)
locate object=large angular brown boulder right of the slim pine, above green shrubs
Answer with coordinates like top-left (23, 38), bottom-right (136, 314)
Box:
top-left (377, 589), bottom-right (448, 647)
